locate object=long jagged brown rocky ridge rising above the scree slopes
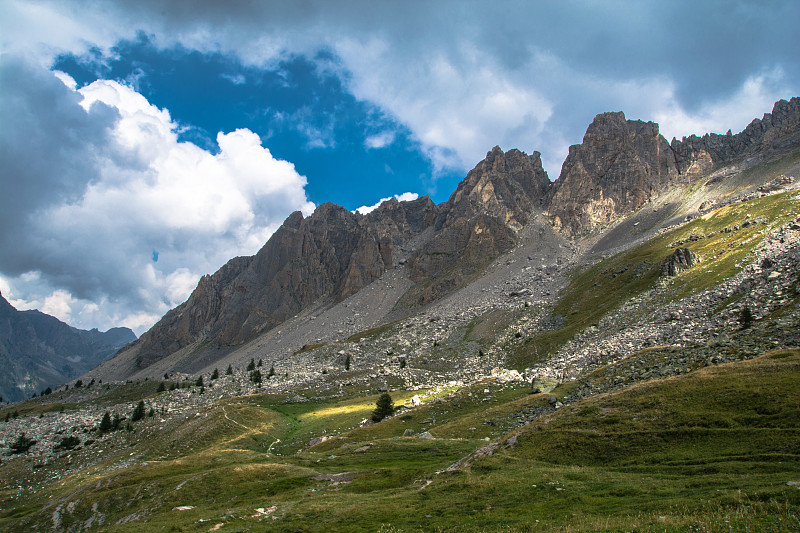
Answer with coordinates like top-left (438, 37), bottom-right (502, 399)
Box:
top-left (99, 97), bottom-right (800, 379)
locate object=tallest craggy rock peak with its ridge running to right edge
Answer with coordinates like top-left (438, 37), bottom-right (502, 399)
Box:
top-left (546, 97), bottom-right (800, 235)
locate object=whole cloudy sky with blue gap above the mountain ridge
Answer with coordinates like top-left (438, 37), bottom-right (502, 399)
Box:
top-left (0, 0), bottom-right (800, 334)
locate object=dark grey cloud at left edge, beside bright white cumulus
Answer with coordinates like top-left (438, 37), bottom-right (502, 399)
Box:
top-left (0, 56), bottom-right (117, 275)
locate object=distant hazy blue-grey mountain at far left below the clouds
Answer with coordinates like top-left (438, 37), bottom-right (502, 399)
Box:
top-left (0, 294), bottom-right (136, 401)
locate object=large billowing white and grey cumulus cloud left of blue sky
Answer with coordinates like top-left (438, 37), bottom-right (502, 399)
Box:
top-left (0, 60), bottom-right (314, 332)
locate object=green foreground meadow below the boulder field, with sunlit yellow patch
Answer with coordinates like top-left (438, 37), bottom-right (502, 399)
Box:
top-left (0, 349), bottom-right (800, 532)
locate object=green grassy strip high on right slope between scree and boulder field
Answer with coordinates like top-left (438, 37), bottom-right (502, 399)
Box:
top-left (509, 192), bottom-right (800, 369)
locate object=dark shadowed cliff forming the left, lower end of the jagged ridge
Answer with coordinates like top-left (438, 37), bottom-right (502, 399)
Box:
top-left (135, 197), bottom-right (436, 367)
